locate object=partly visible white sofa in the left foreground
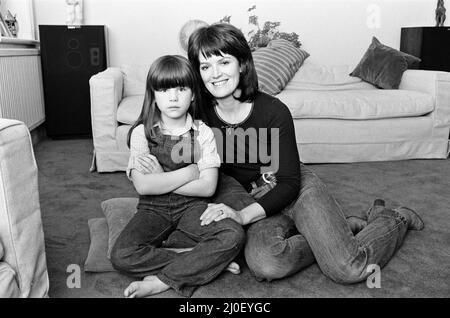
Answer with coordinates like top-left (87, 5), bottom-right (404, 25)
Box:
top-left (0, 118), bottom-right (49, 298)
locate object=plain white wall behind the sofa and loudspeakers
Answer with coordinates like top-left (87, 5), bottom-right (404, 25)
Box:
top-left (33, 0), bottom-right (442, 66)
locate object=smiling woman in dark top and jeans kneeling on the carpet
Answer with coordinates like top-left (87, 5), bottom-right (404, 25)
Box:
top-left (181, 24), bottom-right (423, 283)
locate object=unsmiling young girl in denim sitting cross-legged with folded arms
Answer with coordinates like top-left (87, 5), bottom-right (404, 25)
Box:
top-left (111, 55), bottom-right (245, 297)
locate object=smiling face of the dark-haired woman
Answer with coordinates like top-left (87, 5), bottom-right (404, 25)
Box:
top-left (199, 52), bottom-right (240, 99)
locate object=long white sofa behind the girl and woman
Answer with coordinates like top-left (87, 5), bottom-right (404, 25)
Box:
top-left (90, 60), bottom-right (450, 172)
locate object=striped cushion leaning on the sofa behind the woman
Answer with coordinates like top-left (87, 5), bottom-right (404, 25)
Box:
top-left (253, 39), bottom-right (309, 95)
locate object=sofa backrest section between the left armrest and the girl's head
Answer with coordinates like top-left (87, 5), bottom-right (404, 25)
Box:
top-left (120, 64), bottom-right (150, 97)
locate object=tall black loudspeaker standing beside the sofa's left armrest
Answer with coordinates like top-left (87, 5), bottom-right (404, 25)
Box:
top-left (39, 25), bottom-right (107, 138)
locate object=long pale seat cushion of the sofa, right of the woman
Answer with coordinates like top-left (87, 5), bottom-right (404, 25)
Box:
top-left (277, 89), bottom-right (434, 120)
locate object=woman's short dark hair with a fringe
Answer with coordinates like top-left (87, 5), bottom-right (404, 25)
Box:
top-left (188, 23), bottom-right (258, 103)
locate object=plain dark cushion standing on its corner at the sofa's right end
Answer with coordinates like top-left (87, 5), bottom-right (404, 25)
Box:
top-left (350, 37), bottom-right (420, 89)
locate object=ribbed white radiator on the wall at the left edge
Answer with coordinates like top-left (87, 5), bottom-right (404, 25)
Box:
top-left (0, 49), bottom-right (45, 130)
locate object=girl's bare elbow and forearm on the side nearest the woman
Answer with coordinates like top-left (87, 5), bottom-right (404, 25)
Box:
top-left (174, 168), bottom-right (219, 197)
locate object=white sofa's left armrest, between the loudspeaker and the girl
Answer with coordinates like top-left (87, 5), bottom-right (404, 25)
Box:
top-left (89, 67), bottom-right (123, 160)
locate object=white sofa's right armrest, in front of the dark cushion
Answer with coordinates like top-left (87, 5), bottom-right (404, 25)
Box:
top-left (399, 70), bottom-right (450, 127)
